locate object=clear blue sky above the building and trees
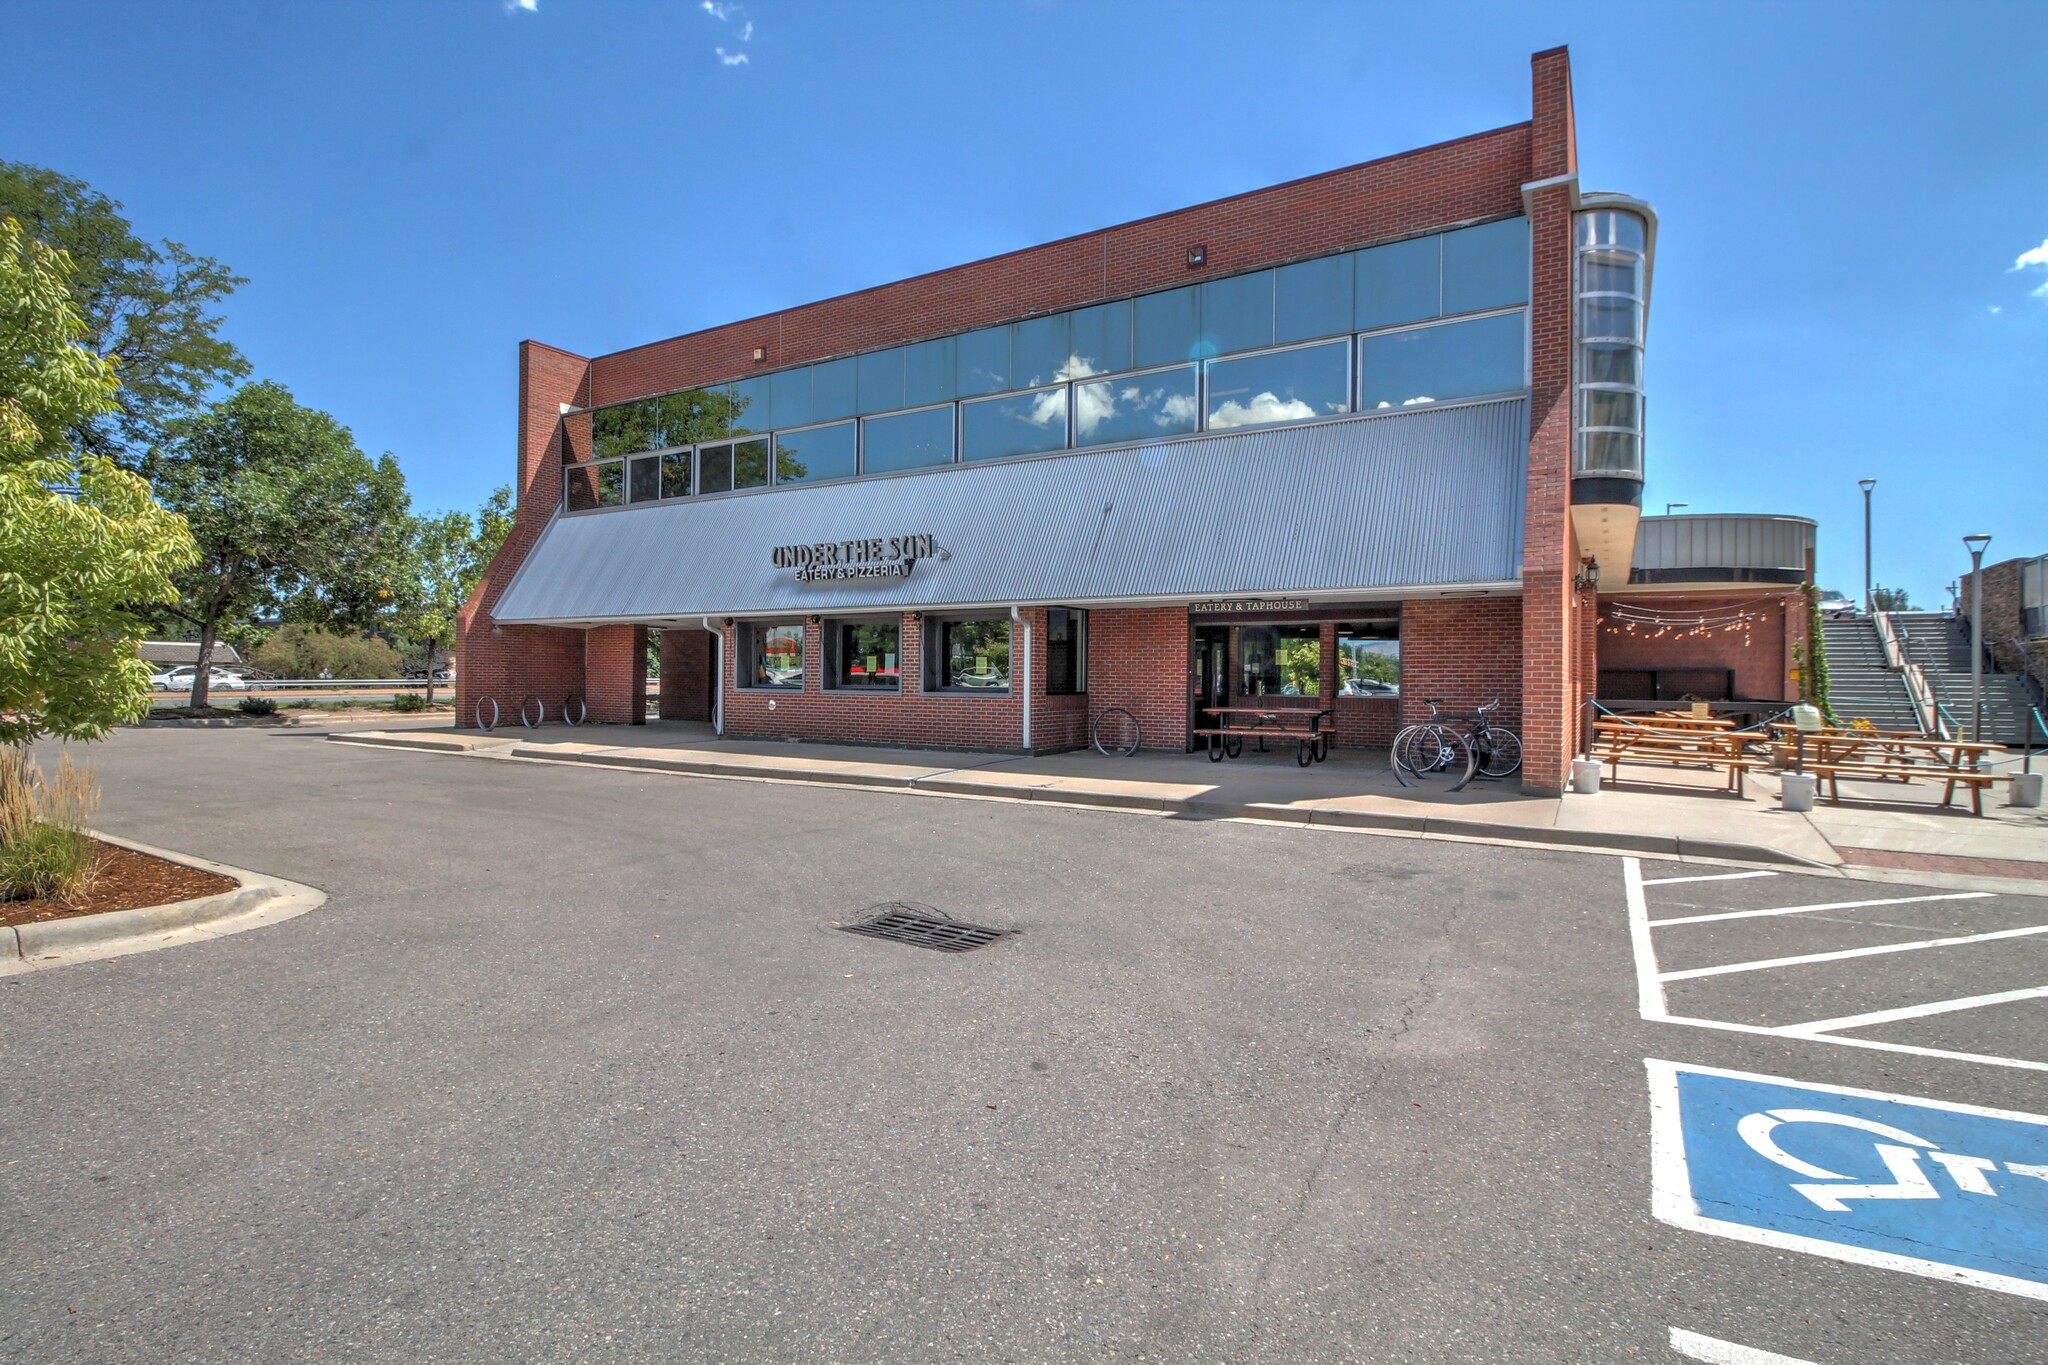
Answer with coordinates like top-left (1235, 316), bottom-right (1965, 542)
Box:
top-left (0, 0), bottom-right (2048, 602)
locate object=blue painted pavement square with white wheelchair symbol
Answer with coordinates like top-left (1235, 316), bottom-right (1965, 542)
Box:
top-left (1647, 1060), bottom-right (2048, 1300)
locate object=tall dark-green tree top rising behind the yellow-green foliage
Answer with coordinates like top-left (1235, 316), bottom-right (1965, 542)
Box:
top-left (0, 162), bottom-right (250, 469)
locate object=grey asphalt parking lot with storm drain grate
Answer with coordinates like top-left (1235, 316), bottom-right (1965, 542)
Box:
top-left (0, 729), bottom-right (2048, 1365)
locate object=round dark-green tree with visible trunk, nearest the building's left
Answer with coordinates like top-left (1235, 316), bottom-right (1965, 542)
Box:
top-left (147, 381), bottom-right (406, 706)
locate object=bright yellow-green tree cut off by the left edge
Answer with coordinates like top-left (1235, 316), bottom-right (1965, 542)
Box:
top-left (0, 217), bottom-right (195, 745)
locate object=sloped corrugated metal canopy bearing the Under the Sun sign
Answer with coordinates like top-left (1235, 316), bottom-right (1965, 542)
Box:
top-left (492, 399), bottom-right (1528, 624)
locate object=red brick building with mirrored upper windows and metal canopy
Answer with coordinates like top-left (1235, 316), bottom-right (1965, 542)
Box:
top-left (457, 49), bottom-right (1655, 788)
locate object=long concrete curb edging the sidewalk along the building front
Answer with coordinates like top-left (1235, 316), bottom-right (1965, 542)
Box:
top-left (328, 735), bottom-right (1841, 872)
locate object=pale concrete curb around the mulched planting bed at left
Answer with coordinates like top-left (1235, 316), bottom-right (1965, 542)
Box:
top-left (0, 831), bottom-right (328, 976)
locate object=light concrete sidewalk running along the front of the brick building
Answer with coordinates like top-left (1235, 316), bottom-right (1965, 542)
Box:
top-left (328, 722), bottom-right (2048, 890)
